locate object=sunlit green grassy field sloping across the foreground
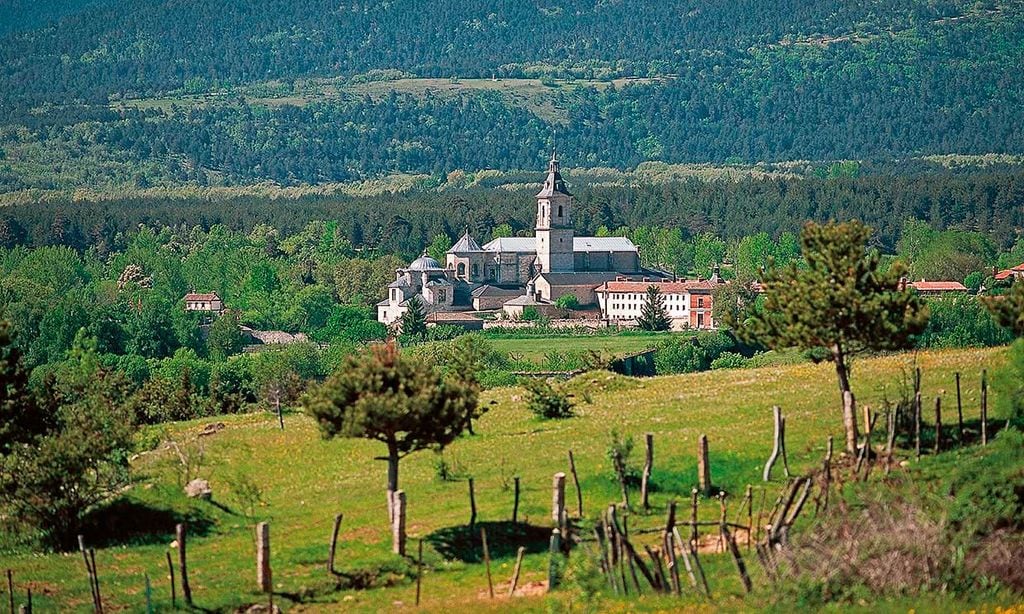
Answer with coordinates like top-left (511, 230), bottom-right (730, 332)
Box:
top-left (0, 340), bottom-right (1004, 612)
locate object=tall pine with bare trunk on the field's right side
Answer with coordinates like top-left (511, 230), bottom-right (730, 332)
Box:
top-left (725, 221), bottom-right (928, 452)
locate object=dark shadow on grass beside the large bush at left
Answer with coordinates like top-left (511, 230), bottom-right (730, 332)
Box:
top-left (82, 497), bottom-right (214, 547)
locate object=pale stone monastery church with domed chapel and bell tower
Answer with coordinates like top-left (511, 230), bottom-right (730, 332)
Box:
top-left (377, 155), bottom-right (665, 324)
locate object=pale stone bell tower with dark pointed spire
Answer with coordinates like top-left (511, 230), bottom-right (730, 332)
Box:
top-left (536, 151), bottom-right (575, 273)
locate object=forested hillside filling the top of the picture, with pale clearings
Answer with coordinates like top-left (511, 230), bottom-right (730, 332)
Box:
top-left (0, 0), bottom-right (1024, 191)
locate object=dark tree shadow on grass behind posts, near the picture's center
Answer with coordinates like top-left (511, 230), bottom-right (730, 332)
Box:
top-left (426, 521), bottom-right (551, 563)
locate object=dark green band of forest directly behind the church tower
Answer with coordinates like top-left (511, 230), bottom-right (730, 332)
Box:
top-left (0, 169), bottom-right (1024, 255)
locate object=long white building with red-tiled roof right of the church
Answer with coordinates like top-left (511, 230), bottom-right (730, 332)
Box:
top-left (594, 275), bottom-right (724, 331)
